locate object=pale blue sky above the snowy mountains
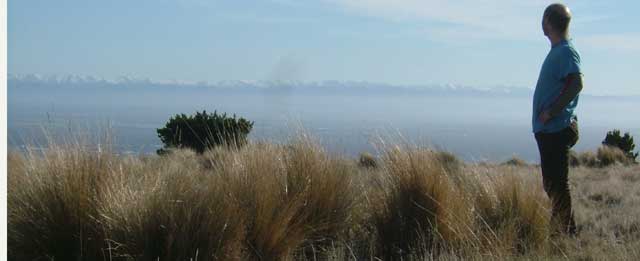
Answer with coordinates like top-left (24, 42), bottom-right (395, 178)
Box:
top-left (7, 0), bottom-right (640, 95)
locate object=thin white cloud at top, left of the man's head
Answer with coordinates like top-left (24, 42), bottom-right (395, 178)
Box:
top-left (326, 0), bottom-right (548, 39)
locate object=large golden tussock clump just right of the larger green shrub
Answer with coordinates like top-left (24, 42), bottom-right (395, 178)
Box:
top-left (208, 140), bottom-right (357, 260)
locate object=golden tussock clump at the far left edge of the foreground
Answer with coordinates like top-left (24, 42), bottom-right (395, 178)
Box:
top-left (7, 143), bottom-right (111, 260)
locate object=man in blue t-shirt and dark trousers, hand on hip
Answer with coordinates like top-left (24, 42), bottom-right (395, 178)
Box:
top-left (532, 4), bottom-right (582, 235)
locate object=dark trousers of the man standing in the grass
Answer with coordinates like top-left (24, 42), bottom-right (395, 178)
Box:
top-left (535, 122), bottom-right (578, 234)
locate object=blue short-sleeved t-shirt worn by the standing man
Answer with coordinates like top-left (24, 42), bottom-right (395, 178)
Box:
top-left (532, 40), bottom-right (580, 133)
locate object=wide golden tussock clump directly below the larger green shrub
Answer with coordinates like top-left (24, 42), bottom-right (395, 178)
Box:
top-left (98, 147), bottom-right (244, 260)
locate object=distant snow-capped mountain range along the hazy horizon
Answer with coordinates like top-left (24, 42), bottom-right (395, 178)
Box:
top-left (8, 74), bottom-right (531, 96)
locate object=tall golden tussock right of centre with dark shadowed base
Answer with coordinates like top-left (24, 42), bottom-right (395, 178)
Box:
top-left (372, 147), bottom-right (471, 259)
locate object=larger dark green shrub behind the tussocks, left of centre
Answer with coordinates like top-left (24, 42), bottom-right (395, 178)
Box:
top-left (157, 111), bottom-right (253, 154)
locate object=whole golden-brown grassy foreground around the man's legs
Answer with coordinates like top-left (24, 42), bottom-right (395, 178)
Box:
top-left (8, 138), bottom-right (640, 260)
